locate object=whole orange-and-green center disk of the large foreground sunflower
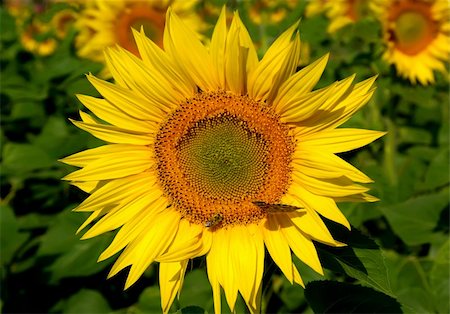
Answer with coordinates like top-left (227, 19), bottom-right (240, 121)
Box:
top-left (155, 91), bottom-right (294, 227)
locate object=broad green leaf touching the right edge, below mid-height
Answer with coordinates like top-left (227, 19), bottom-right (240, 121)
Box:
top-left (381, 189), bottom-right (449, 245)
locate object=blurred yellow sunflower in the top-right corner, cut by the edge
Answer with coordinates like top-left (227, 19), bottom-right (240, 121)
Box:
top-left (381, 0), bottom-right (450, 85)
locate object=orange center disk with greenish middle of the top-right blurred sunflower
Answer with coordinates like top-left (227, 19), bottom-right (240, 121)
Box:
top-left (393, 6), bottom-right (437, 55)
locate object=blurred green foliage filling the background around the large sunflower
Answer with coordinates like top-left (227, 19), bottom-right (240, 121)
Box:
top-left (0, 0), bottom-right (450, 313)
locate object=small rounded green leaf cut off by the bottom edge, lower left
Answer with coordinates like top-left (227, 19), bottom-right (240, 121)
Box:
top-left (63, 289), bottom-right (111, 314)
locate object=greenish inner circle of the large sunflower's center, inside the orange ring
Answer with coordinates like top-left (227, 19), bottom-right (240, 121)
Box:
top-left (178, 115), bottom-right (267, 199)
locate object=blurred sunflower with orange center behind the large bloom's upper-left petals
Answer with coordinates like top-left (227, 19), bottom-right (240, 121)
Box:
top-left (75, 0), bottom-right (203, 70)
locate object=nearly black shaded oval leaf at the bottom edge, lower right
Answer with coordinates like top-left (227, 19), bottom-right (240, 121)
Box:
top-left (305, 281), bottom-right (402, 313)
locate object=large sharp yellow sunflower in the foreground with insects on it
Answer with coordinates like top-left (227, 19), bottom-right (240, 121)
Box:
top-left (59, 9), bottom-right (384, 313)
